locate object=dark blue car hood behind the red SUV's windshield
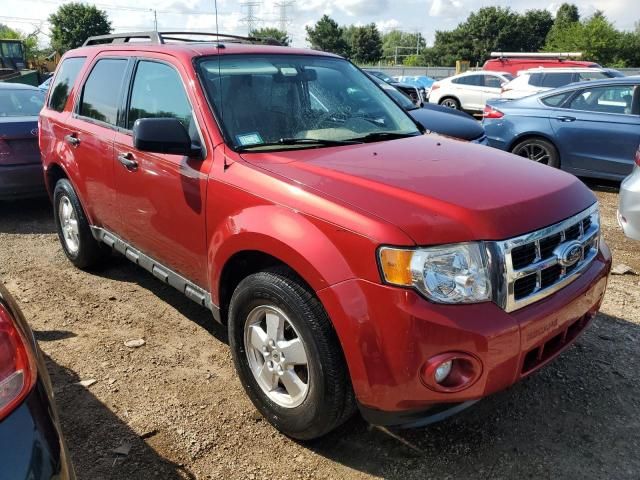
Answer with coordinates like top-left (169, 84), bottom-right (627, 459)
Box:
top-left (408, 105), bottom-right (484, 140)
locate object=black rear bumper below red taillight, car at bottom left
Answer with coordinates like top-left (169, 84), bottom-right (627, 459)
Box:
top-left (0, 378), bottom-right (75, 480)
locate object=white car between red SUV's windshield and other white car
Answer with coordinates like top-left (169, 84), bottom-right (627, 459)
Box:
top-left (429, 70), bottom-right (514, 113)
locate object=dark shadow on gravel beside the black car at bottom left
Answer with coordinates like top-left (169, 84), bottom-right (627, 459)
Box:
top-left (46, 350), bottom-right (195, 480)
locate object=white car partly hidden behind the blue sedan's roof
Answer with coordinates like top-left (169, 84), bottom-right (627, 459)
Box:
top-left (500, 67), bottom-right (624, 100)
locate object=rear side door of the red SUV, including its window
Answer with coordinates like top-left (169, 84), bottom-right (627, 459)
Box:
top-left (63, 55), bottom-right (129, 230)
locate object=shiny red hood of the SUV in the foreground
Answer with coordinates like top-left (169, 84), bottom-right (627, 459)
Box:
top-left (242, 135), bottom-right (595, 245)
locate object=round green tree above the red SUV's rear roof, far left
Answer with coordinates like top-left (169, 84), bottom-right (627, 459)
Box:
top-left (49, 3), bottom-right (111, 54)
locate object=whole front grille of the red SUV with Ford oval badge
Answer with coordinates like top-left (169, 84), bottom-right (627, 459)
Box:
top-left (497, 203), bottom-right (600, 312)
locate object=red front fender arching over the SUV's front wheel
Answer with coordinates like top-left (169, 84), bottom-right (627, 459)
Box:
top-left (208, 205), bottom-right (377, 305)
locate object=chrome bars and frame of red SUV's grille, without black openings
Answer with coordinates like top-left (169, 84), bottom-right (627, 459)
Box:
top-left (495, 202), bottom-right (600, 312)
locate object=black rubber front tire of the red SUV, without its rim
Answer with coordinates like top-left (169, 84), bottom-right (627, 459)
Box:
top-left (229, 268), bottom-right (356, 440)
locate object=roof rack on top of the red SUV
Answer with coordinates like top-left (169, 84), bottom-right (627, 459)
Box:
top-left (82, 31), bottom-right (282, 47)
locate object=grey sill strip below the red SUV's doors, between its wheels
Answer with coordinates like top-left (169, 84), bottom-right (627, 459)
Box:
top-left (91, 227), bottom-right (222, 322)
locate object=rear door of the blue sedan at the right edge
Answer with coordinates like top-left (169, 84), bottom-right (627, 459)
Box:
top-left (551, 84), bottom-right (640, 179)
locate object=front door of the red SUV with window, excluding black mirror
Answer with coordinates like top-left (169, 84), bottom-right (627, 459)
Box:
top-left (114, 58), bottom-right (212, 288)
